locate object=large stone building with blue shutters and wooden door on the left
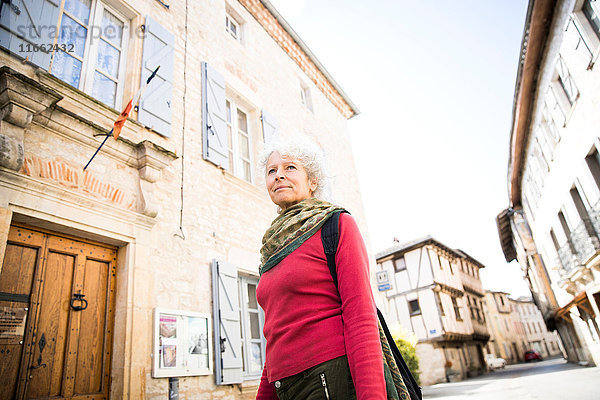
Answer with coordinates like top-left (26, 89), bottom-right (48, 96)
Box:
top-left (0, 0), bottom-right (368, 399)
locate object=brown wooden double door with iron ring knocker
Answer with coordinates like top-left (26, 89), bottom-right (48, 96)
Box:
top-left (0, 226), bottom-right (116, 400)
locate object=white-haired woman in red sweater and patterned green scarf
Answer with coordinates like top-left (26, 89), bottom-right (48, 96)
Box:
top-left (256, 141), bottom-right (386, 400)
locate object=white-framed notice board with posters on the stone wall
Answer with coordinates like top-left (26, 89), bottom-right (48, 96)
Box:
top-left (152, 308), bottom-right (212, 378)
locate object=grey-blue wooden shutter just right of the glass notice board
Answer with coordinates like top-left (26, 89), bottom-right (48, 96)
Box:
top-left (212, 260), bottom-right (243, 385)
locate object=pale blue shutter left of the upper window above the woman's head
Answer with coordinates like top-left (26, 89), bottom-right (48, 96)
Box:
top-left (202, 62), bottom-right (229, 169)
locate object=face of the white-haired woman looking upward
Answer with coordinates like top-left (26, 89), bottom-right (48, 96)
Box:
top-left (267, 152), bottom-right (317, 210)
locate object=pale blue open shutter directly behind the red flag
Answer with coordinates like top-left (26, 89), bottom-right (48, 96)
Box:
top-left (138, 16), bottom-right (175, 137)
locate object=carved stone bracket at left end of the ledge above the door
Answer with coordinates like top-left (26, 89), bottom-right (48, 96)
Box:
top-left (0, 66), bottom-right (62, 171)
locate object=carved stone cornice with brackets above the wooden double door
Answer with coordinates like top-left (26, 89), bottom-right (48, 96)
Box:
top-left (0, 67), bottom-right (177, 218)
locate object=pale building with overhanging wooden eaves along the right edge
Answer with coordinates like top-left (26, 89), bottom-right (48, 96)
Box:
top-left (497, 0), bottom-right (600, 365)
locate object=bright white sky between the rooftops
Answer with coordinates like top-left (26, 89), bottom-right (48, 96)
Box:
top-left (270, 0), bottom-right (530, 297)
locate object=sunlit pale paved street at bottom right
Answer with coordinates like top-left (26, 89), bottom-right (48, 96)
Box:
top-left (423, 358), bottom-right (600, 400)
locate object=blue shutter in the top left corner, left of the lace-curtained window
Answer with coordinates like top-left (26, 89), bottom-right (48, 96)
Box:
top-left (0, 0), bottom-right (60, 70)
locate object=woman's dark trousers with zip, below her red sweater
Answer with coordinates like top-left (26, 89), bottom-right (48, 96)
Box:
top-left (274, 356), bottom-right (356, 400)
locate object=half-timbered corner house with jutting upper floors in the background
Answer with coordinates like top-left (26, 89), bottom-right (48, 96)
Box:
top-left (376, 237), bottom-right (489, 385)
